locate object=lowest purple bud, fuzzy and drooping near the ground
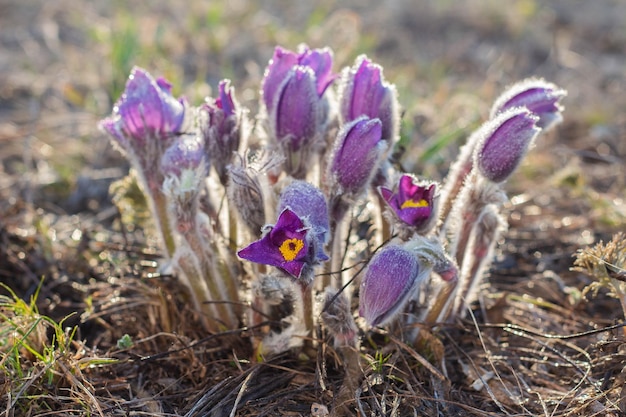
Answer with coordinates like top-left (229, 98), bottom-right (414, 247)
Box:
top-left (359, 244), bottom-right (422, 326)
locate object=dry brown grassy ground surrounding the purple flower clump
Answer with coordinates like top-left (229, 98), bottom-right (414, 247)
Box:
top-left (0, 0), bottom-right (626, 416)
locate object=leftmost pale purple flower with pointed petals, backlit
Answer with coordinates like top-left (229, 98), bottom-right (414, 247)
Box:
top-left (100, 67), bottom-right (186, 153)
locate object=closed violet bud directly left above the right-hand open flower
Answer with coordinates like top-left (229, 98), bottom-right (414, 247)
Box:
top-left (329, 116), bottom-right (386, 195)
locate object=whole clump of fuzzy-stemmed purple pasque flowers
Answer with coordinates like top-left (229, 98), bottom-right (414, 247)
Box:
top-left (101, 45), bottom-right (566, 404)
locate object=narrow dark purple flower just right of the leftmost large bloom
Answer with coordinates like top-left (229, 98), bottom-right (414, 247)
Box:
top-left (199, 80), bottom-right (245, 184)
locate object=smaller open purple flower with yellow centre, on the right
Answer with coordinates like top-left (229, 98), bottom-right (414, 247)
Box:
top-left (378, 174), bottom-right (438, 233)
